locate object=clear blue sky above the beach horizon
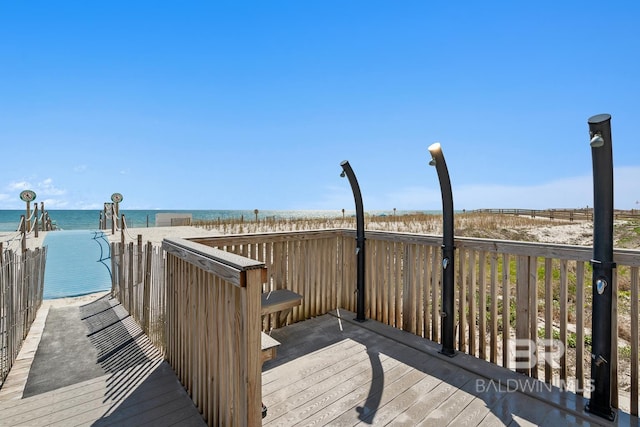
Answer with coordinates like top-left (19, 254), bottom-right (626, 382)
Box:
top-left (0, 0), bottom-right (640, 210)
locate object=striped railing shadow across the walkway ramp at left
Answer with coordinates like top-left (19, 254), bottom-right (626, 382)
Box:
top-left (80, 295), bottom-right (203, 426)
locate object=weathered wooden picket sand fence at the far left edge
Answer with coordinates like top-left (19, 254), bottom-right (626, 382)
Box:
top-left (0, 248), bottom-right (47, 385)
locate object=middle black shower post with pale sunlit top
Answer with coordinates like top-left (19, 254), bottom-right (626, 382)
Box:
top-left (429, 142), bottom-right (456, 356)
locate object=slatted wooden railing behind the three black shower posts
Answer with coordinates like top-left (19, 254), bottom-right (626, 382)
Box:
top-left (114, 230), bottom-right (640, 415)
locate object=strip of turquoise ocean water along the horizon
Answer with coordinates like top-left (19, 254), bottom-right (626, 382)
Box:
top-left (0, 209), bottom-right (434, 232)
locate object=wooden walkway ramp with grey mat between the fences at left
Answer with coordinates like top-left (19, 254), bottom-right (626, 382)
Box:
top-left (0, 296), bottom-right (205, 427)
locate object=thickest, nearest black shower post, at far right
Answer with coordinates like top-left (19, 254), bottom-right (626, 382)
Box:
top-left (587, 114), bottom-right (616, 420)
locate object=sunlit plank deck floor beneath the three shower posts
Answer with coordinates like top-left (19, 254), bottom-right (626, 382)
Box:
top-left (262, 310), bottom-right (638, 426)
